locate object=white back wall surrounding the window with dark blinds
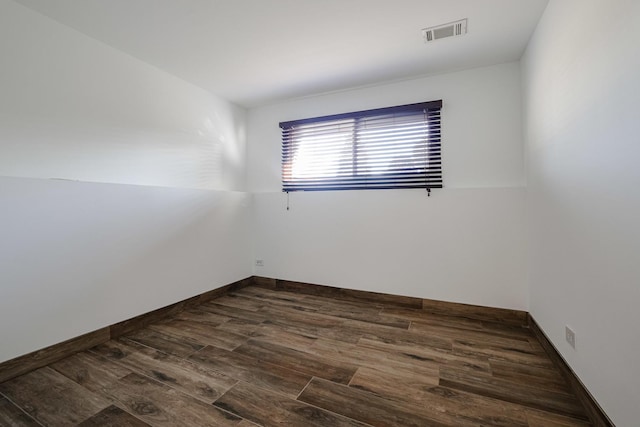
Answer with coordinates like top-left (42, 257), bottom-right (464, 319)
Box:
top-left (248, 63), bottom-right (527, 309)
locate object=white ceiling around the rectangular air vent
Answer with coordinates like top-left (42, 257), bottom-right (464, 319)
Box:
top-left (16, 0), bottom-right (548, 107)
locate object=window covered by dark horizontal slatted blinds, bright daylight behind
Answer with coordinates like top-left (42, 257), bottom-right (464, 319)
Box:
top-left (280, 101), bottom-right (442, 192)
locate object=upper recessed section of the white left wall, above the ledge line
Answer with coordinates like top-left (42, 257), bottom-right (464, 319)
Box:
top-left (0, 0), bottom-right (245, 190)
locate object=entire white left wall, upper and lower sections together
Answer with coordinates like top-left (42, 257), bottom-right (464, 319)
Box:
top-left (0, 0), bottom-right (252, 361)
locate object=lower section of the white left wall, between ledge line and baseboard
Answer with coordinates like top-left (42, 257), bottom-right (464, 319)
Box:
top-left (0, 177), bottom-right (251, 361)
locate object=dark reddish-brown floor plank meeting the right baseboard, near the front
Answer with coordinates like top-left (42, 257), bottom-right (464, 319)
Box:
top-left (440, 368), bottom-right (587, 419)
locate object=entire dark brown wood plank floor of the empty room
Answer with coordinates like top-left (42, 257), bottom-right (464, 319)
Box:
top-left (0, 287), bottom-right (589, 427)
